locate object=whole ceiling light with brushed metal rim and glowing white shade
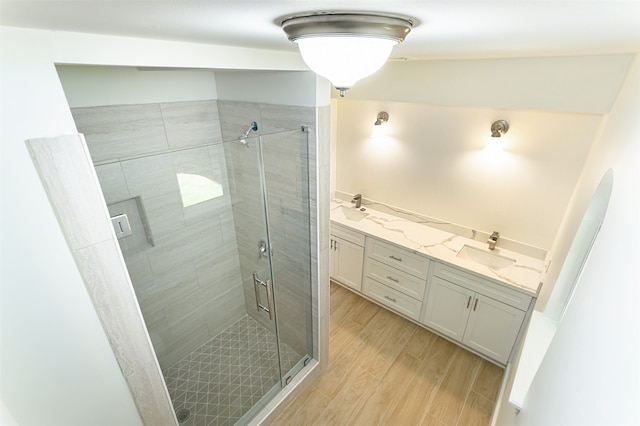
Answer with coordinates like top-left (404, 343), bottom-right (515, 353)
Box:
top-left (281, 12), bottom-right (413, 96)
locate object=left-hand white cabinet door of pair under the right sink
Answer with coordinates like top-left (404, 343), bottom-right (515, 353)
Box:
top-left (423, 277), bottom-right (475, 341)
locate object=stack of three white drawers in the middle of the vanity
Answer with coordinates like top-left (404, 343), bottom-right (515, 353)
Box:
top-left (362, 237), bottom-right (430, 321)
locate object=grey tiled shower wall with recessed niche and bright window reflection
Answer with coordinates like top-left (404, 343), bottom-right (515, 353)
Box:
top-left (72, 101), bottom-right (245, 369)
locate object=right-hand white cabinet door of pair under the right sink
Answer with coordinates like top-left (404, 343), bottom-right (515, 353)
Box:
top-left (462, 294), bottom-right (525, 364)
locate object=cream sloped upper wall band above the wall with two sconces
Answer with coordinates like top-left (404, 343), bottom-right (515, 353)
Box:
top-left (347, 55), bottom-right (632, 114)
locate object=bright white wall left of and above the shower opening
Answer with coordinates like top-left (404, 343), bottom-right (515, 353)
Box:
top-left (0, 27), bottom-right (304, 425)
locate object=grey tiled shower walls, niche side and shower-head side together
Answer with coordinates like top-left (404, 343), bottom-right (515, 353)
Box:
top-left (72, 101), bottom-right (315, 368)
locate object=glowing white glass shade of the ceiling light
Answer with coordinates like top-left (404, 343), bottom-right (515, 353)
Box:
top-left (296, 36), bottom-right (397, 96)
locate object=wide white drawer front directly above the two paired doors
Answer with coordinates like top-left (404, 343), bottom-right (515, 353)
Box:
top-left (433, 262), bottom-right (532, 311)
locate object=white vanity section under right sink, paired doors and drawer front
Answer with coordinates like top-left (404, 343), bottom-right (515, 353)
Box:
top-left (422, 262), bottom-right (532, 364)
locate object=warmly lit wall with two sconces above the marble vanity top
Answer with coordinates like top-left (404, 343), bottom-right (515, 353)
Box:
top-left (335, 95), bottom-right (601, 249)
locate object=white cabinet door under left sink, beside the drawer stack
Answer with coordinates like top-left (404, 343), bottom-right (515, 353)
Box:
top-left (331, 235), bottom-right (364, 291)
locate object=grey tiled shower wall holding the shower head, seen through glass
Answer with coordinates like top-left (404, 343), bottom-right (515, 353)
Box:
top-left (218, 101), bottom-right (316, 355)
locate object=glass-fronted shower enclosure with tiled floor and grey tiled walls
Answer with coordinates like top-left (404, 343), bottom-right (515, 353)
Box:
top-left (84, 107), bottom-right (313, 425)
